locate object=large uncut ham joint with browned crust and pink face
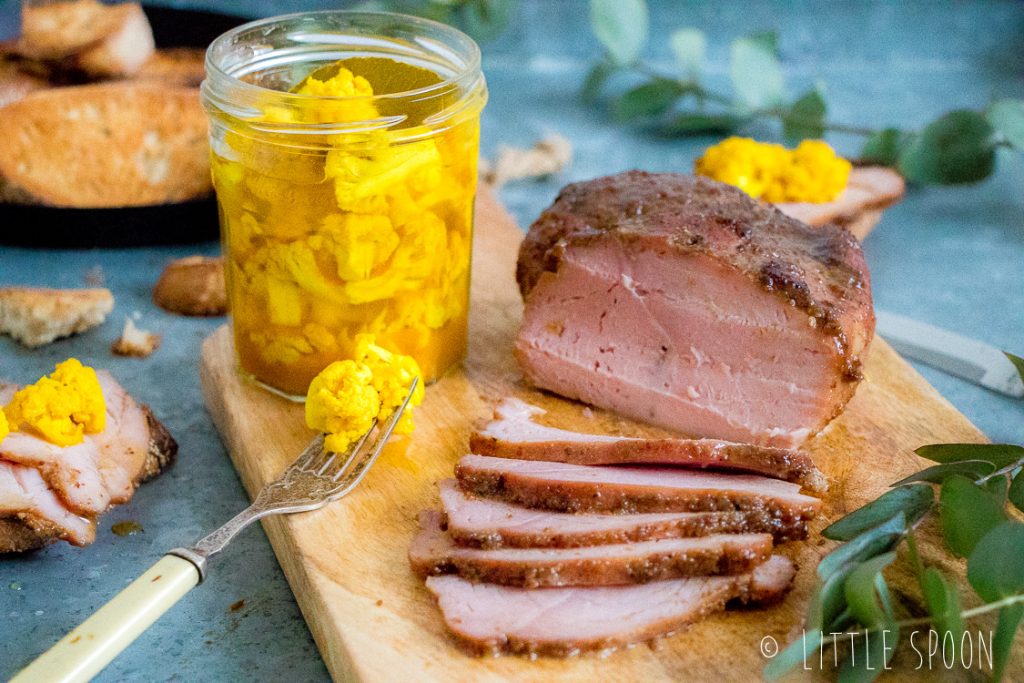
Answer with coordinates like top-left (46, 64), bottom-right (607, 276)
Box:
top-left (515, 171), bottom-right (874, 447)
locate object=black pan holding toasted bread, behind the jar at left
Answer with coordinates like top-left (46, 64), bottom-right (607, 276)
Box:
top-left (0, 6), bottom-right (249, 248)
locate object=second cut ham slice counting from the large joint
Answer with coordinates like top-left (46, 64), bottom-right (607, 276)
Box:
top-left (456, 455), bottom-right (821, 524)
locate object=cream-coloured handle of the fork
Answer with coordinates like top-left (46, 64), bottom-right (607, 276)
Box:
top-left (9, 555), bottom-right (199, 683)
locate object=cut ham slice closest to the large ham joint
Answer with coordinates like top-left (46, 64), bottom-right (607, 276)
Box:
top-left (469, 397), bottom-right (827, 490)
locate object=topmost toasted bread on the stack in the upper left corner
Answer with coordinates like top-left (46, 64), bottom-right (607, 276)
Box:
top-left (18, 0), bottom-right (154, 76)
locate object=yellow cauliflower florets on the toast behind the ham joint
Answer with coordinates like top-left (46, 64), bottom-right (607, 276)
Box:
top-left (694, 137), bottom-right (852, 204)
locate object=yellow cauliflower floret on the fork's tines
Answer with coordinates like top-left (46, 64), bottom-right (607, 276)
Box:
top-left (306, 335), bottom-right (423, 453)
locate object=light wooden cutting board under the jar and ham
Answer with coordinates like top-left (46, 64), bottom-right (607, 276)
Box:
top-left (202, 188), bottom-right (1024, 683)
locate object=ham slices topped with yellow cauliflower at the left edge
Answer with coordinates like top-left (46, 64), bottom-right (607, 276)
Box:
top-left (0, 359), bottom-right (177, 553)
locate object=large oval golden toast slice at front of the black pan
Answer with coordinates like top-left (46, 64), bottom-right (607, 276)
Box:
top-left (0, 82), bottom-right (213, 208)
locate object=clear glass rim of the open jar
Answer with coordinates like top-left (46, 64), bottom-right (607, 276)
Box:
top-left (203, 10), bottom-right (482, 113)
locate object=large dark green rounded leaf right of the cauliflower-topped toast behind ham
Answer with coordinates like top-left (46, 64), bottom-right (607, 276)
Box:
top-left (899, 110), bottom-right (995, 184)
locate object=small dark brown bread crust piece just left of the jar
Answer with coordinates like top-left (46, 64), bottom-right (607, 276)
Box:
top-left (153, 256), bottom-right (227, 315)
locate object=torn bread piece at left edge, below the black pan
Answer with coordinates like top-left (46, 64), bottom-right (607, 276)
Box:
top-left (0, 287), bottom-right (114, 348)
